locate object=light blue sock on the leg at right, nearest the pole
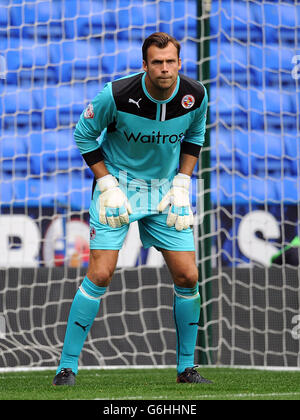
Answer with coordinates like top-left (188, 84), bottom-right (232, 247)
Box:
top-left (173, 283), bottom-right (201, 374)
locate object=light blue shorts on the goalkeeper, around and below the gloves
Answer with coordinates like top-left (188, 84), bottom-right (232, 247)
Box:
top-left (89, 182), bottom-right (195, 251)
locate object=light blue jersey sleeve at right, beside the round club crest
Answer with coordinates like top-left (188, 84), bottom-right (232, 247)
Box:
top-left (183, 85), bottom-right (208, 146)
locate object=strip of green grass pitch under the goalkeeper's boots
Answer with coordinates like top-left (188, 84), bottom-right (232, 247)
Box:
top-left (0, 367), bottom-right (300, 401)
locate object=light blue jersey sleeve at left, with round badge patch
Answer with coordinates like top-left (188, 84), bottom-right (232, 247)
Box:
top-left (74, 83), bottom-right (116, 164)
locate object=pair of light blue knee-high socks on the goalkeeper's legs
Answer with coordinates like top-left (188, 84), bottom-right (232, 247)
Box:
top-left (56, 277), bottom-right (201, 374)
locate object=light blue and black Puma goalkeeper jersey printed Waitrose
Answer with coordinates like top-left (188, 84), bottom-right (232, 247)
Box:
top-left (74, 73), bottom-right (207, 181)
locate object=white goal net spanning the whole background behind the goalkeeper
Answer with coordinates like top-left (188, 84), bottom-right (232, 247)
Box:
top-left (0, 0), bottom-right (300, 368)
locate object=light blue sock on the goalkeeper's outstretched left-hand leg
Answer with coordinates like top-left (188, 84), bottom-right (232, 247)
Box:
top-left (56, 277), bottom-right (106, 374)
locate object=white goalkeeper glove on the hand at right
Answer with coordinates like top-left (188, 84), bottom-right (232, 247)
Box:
top-left (157, 173), bottom-right (193, 230)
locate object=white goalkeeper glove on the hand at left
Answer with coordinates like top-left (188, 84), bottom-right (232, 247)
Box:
top-left (97, 174), bottom-right (132, 228)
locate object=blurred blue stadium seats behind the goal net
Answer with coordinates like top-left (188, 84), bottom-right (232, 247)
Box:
top-left (0, 0), bottom-right (300, 210)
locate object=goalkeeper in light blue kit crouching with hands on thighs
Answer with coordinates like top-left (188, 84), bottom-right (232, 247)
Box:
top-left (53, 32), bottom-right (210, 385)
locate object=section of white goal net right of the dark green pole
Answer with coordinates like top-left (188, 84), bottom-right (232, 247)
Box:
top-left (209, 0), bottom-right (300, 367)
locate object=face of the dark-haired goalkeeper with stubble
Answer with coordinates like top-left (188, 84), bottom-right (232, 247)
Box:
top-left (143, 42), bottom-right (181, 95)
